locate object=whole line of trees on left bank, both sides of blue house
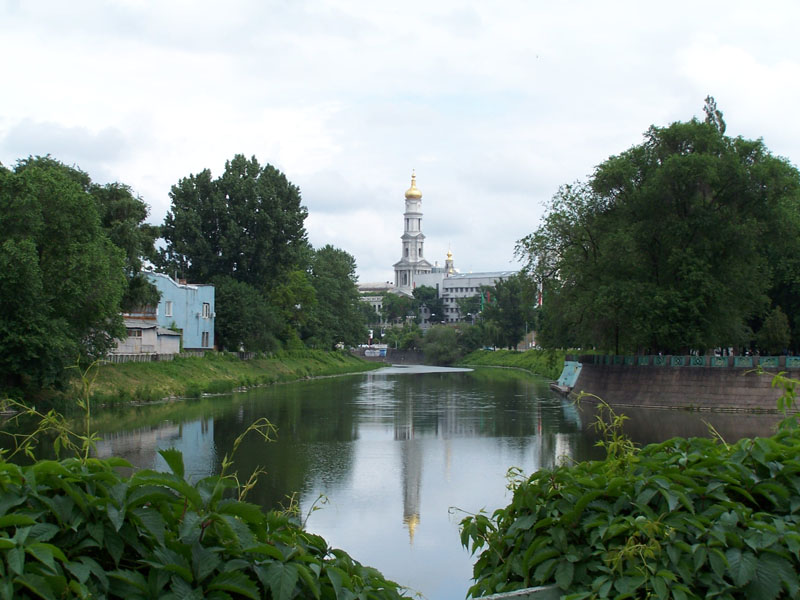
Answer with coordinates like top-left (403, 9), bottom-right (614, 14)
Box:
top-left (0, 155), bottom-right (365, 393)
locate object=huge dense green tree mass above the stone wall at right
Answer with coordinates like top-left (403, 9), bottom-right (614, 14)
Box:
top-left (518, 98), bottom-right (800, 354)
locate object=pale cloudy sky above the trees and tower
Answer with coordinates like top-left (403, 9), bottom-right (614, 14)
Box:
top-left (0, 0), bottom-right (800, 282)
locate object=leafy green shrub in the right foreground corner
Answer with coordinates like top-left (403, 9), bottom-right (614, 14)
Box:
top-left (461, 406), bottom-right (800, 600)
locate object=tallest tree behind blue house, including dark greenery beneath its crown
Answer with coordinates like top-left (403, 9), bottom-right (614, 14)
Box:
top-left (158, 154), bottom-right (312, 350)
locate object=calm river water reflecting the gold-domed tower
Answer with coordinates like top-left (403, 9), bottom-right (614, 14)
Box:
top-left (65, 367), bottom-right (777, 600)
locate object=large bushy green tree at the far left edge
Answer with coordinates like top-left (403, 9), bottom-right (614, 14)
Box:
top-left (0, 157), bottom-right (126, 388)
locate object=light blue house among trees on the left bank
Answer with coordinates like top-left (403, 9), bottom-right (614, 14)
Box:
top-left (147, 273), bottom-right (215, 350)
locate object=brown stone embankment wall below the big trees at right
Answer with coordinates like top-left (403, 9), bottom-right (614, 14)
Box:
top-left (570, 357), bottom-right (800, 411)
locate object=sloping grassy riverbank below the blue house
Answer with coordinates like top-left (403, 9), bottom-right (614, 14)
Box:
top-left (81, 350), bottom-right (383, 404)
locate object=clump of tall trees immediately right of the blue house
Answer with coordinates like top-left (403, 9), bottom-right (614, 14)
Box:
top-left (159, 155), bottom-right (366, 351)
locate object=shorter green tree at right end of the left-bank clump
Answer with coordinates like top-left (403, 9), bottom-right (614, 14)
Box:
top-left (311, 244), bottom-right (367, 349)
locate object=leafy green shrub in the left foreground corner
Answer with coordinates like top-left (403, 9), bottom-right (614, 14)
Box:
top-left (0, 450), bottom-right (402, 600)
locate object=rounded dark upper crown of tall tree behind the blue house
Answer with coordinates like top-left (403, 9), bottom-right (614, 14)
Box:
top-left (160, 154), bottom-right (308, 292)
